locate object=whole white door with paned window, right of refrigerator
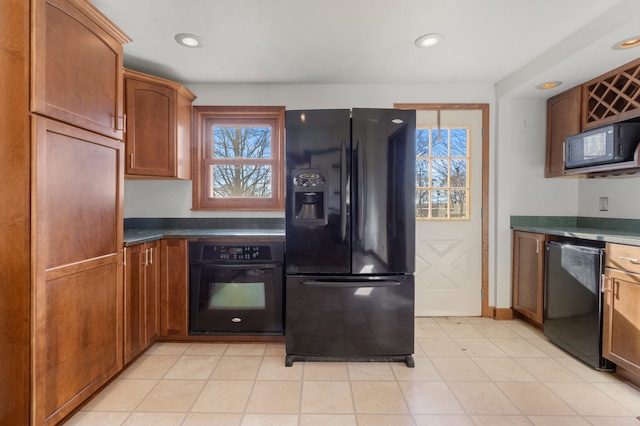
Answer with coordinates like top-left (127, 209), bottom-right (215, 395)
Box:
top-left (415, 109), bottom-right (482, 316)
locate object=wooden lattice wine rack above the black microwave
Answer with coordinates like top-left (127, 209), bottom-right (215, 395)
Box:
top-left (582, 59), bottom-right (640, 130)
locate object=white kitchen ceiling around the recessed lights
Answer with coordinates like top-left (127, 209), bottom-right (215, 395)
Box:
top-left (92, 0), bottom-right (640, 97)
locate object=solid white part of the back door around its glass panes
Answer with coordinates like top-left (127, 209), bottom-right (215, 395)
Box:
top-left (416, 109), bottom-right (482, 316)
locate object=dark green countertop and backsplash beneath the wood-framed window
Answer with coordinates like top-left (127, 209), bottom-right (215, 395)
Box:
top-left (124, 218), bottom-right (284, 247)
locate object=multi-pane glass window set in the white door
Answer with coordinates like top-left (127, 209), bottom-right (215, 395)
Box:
top-left (416, 127), bottom-right (470, 220)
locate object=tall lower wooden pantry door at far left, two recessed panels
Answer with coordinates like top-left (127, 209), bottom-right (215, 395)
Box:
top-left (32, 118), bottom-right (123, 424)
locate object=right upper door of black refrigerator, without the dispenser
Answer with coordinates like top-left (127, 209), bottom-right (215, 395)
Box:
top-left (351, 109), bottom-right (415, 274)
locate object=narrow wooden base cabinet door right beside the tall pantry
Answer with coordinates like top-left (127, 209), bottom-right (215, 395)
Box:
top-left (124, 244), bottom-right (146, 364)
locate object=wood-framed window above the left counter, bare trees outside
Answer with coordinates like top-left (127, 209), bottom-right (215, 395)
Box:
top-left (193, 106), bottom-right (285, 210)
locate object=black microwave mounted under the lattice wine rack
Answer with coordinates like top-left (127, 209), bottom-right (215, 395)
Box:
top-left (564, 123), bottom-right (640, 169)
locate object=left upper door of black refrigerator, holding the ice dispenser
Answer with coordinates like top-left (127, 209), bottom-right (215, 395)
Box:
top-left (285, 110), bottom-right (351, 273)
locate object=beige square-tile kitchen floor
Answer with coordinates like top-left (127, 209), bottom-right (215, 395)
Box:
top-left (67, 317), bottom-right (640, 426)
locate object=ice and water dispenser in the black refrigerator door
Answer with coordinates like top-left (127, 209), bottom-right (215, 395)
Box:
top-left (291, 169), bottom-right (328, 226)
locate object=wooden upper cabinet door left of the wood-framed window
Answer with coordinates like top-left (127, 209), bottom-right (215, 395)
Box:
top-left (125, 78), bottom-right (176, 177)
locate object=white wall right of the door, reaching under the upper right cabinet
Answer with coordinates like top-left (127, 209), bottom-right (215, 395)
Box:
top-left (489, 97), bottom-right (578, 308)
